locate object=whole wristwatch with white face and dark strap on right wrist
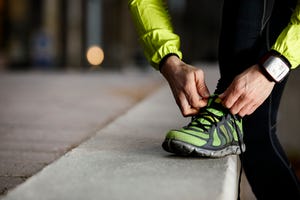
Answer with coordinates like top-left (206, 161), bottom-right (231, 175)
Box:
top-left (260, 52), bottom-right (290, 83)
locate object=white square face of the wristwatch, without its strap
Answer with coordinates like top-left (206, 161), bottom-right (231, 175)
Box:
top-left (264, 56), bottom-right (290, 82)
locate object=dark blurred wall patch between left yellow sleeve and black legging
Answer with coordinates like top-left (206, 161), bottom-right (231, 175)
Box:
top-left (169, 0), bottom-right (223, 62)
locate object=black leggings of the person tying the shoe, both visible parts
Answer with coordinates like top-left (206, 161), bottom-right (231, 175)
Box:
top-left (216, 0), bottom-right (300, 199)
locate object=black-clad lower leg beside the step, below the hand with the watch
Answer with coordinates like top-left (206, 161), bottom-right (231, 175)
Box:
top-left (242, 78), bottom-right (300, 199)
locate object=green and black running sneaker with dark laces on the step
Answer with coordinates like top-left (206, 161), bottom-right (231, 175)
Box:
top-left (162, 95), bottom-right (246, 158)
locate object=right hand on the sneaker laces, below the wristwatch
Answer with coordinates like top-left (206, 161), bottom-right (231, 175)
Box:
top-left (220, 65), bottom-right (275, 117)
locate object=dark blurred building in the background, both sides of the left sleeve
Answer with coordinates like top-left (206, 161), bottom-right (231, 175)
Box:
top-left (0, 0), bottom-right (221, 70)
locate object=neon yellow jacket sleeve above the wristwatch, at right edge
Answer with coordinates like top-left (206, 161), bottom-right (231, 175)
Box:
top-left (271, 0), bottom-right (300, 69)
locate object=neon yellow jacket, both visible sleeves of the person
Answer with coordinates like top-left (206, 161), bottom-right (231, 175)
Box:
top-left (129, 0), bottom-right (300, 69)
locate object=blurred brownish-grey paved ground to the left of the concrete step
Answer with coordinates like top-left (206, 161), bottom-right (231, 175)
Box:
top-left (0, 71), bottom-right (162, 195)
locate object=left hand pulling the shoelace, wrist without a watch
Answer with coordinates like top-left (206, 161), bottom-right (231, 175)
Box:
top-left (161, 56), bottom-right (210, 117)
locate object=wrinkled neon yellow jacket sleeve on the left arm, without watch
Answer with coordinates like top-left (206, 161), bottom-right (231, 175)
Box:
top-left (128, 0), bottom-right (182, 70)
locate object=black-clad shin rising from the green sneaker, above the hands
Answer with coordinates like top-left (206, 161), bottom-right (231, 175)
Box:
top-left (216, 0), bottom-right (264, 94)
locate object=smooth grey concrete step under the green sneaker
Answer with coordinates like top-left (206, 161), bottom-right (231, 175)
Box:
top-left (3, 80), bottom-right (238, 200)
